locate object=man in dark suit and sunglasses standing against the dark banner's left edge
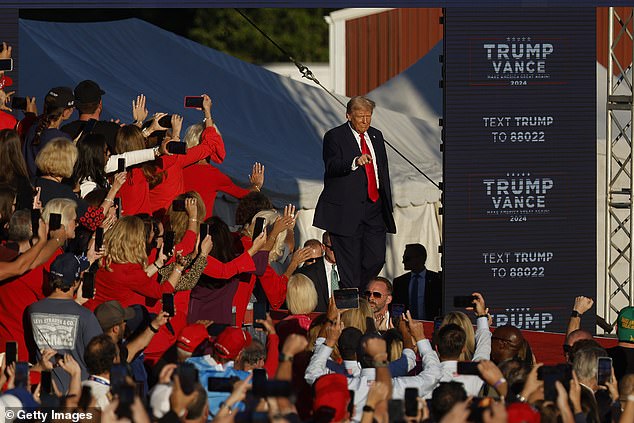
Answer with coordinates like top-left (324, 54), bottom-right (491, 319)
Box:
top-left (392, 244), bottom-right (442, 320)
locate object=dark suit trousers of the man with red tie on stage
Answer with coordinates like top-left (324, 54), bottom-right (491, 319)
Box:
top-left (330, 198), bottom-right (387, 292)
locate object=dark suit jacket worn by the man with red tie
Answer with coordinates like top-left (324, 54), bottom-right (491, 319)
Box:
top-left (313, 122), bottom-right (396, 236)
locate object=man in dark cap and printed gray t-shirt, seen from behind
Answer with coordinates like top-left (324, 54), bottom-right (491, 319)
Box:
top-left (25, 253), bottom-right (102, 393)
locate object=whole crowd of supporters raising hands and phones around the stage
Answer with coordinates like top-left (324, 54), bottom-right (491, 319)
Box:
top-left (0, 43), bottom-right (634, 423)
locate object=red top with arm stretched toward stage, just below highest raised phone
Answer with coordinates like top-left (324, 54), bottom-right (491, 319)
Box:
top-left (183, 163), bottom-right (251, 219)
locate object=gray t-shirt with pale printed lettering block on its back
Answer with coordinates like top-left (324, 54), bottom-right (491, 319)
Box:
top-left (25, 298), bottom-right (102, 392)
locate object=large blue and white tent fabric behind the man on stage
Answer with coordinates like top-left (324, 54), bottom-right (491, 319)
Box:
top-left (18, 19), bottom-right (442, 277)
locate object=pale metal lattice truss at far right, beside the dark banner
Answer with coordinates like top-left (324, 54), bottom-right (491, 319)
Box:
top-left (603, 7), bottom-right (634, 332)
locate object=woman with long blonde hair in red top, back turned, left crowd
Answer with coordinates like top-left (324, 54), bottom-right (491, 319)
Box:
top-left (85, 216), bottom-right (183, 311)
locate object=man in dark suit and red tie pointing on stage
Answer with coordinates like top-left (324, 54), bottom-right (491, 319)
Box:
top-left (313, 97), bottom-right (396, 291)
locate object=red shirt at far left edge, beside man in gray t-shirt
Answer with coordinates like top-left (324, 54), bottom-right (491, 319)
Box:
top-left (0, 249), bottom-right (62, 361)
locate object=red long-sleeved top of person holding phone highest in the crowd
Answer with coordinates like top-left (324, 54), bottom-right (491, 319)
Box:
top-left (150, 126), bottom-right (226, 212)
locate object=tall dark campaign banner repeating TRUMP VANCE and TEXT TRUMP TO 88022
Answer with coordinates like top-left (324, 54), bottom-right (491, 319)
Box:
top-left (443, 7), bottom-right (597, 332)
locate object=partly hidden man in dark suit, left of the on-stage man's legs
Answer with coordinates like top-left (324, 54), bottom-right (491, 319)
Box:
top-left (295, 232), bottom-right (339, 313)
